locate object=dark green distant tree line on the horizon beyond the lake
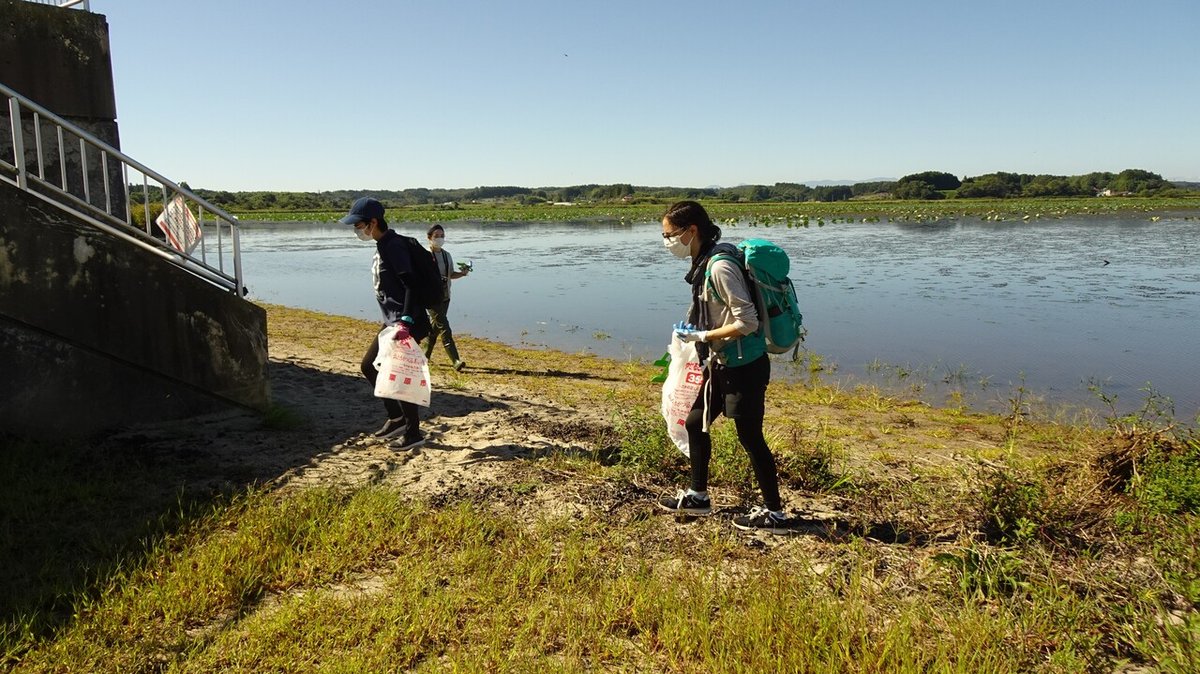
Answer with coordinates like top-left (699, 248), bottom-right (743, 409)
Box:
top-left (131, 169), bottom-right (1200, 211)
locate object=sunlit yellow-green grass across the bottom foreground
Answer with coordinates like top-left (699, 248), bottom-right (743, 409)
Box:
top-left (10, 488), bottom-right (1187, 672)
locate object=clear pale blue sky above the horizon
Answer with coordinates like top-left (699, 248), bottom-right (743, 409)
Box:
top-left (91, 0), bottom-right (1200, 191)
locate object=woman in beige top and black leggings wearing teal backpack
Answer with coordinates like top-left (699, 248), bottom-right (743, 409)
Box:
top-left (659, 201), bottom-right (792, 534)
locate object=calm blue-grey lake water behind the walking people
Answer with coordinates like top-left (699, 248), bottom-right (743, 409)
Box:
top-left (241, 213), bottom-right (1200, 421)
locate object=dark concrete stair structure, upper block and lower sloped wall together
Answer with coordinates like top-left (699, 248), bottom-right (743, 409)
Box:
top-left (0, 0), bottom-right (269, 438)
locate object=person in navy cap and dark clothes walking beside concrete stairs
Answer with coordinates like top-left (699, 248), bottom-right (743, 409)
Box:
top-left (338, 197), bottom-right (430, 451)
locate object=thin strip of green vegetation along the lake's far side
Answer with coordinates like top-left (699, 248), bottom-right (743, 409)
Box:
top-left (235, 197), bottom-right (1200, 227)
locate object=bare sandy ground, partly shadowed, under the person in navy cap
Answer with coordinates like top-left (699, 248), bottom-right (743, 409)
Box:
top-left (117, 343), bottom-right (604, 506)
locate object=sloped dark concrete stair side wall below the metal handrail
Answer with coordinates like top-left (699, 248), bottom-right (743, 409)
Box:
top-left (0, 182), bottom-right (269, 437)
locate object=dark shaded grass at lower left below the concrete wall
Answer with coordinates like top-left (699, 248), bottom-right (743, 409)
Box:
top-left (0, 429), bottom-right (231, 655)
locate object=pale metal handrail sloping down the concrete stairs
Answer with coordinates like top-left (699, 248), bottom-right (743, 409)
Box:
top-left (0, 84), bottom-right (246, 295)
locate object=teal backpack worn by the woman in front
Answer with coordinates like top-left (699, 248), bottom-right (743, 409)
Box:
top-left (708, 239), bottom-right (808, 360)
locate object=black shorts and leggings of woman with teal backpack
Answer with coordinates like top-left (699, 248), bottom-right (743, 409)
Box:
top-left (685, 354), bottom-right (784, 510)
